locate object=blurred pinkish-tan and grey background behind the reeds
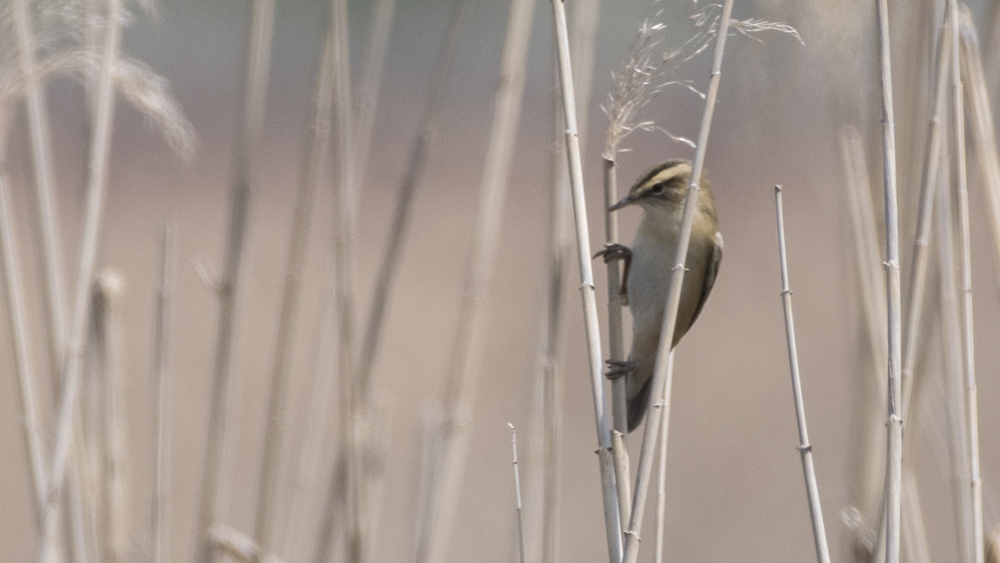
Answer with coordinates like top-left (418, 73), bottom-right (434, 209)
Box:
top-left (0, 0), bottom-right (1000, 561)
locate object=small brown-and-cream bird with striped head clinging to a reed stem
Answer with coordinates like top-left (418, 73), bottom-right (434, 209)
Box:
top-left (595, 160), bottom-right (723, 432)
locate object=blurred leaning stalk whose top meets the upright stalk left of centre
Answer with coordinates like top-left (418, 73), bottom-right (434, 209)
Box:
top-left (254, 0), bottom-right (334, 549)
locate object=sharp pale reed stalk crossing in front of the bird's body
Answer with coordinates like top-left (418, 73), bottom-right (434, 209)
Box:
top-left (624, 6), bottom-right (733, 563)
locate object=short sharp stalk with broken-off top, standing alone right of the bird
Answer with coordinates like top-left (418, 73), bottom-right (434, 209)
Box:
top-left (774, 186), bottom-right (830, 563)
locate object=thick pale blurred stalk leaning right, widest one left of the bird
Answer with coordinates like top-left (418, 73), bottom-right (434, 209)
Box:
top-left (417, 0), bottom-right (535, 562)
